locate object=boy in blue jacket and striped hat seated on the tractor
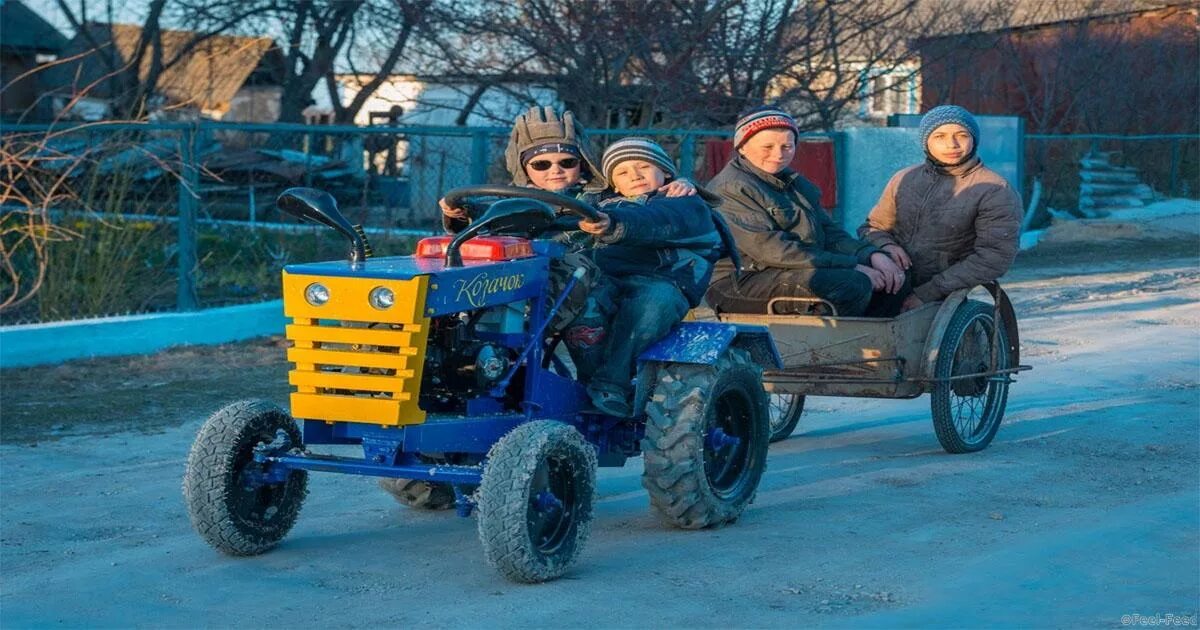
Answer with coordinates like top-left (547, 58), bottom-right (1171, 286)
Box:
top-left (568, 137), bottom-right (727, 416)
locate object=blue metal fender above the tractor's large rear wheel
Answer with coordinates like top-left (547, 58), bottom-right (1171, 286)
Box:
top-left (637, 322), bottom-right (784, 370)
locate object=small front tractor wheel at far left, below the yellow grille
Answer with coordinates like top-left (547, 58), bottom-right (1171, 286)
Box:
top-left (184, 401), bottom-right (308, 556)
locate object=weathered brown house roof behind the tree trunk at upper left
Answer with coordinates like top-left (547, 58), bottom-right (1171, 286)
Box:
top-left (48, 22), bottom-right (283, 109)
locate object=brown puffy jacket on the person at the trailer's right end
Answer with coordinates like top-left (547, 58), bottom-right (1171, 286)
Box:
top-left (858, 157), bottom-right (1021, 302)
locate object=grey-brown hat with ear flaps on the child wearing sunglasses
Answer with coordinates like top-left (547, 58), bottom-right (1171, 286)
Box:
top-left (504, 107), bottom-right (608, 191)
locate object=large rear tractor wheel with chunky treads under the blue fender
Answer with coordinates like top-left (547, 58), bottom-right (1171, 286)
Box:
top-left (642, 348), bottom-right (769, 529)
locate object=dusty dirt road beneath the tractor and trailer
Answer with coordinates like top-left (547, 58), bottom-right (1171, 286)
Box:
top-left (0, 249), bottom-right (1200, 628)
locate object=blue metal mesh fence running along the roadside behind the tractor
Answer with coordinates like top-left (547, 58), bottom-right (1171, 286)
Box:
top-left (0, 122), bottom-right (1200, 325)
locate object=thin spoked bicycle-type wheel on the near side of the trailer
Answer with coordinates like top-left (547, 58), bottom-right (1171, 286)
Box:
top-left (930, 300), bottom-right (1009, 452)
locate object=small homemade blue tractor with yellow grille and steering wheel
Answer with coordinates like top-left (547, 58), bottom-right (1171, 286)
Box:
top-left (184, 186), bottom-right (780, 582)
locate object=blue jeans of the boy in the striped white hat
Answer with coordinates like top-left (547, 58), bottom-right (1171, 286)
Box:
top-left (566, 276), bottom-right (688, 398)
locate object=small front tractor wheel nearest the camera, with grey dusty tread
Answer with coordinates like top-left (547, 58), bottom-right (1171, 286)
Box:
top-left (476, 420), bottom-right (596, 583)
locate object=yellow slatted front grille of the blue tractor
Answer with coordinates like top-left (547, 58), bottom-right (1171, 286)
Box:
top-left (284, 274), bottom-right (428, 426)
